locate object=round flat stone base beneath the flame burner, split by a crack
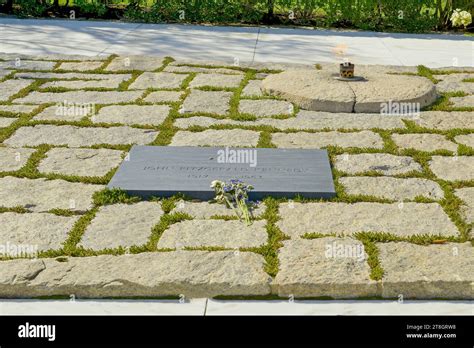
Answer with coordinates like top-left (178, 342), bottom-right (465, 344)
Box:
top-left (262, 69), bottom-right (437, 114)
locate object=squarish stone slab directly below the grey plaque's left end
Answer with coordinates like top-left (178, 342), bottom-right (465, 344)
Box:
top-left (79, 202), bottom-right (163, 250)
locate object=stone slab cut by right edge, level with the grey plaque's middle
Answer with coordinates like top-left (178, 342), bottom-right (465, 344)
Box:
top-left (429, 156), bottom-right (474, 181)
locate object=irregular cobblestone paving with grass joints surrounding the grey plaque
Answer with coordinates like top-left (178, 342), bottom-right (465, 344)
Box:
top-left (0, 56), bottom-right (474, 299)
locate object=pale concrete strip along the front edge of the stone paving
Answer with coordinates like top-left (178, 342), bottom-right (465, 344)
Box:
top-left (0, 299), bottom-right (473, 316)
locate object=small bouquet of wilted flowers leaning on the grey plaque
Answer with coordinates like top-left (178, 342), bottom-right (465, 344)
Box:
top-left (211, 179), bottom-right (253, 226)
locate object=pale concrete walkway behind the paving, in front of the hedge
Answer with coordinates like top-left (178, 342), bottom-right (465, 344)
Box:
top-left (0, 18), bottom-right (474, 68)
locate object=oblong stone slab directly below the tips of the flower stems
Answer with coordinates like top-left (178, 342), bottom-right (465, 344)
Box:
top-left (158, 220), bottom-right (268, 249)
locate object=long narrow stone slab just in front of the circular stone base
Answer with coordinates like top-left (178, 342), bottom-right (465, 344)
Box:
top-left (175, 110), bottom-right (405, 130)
